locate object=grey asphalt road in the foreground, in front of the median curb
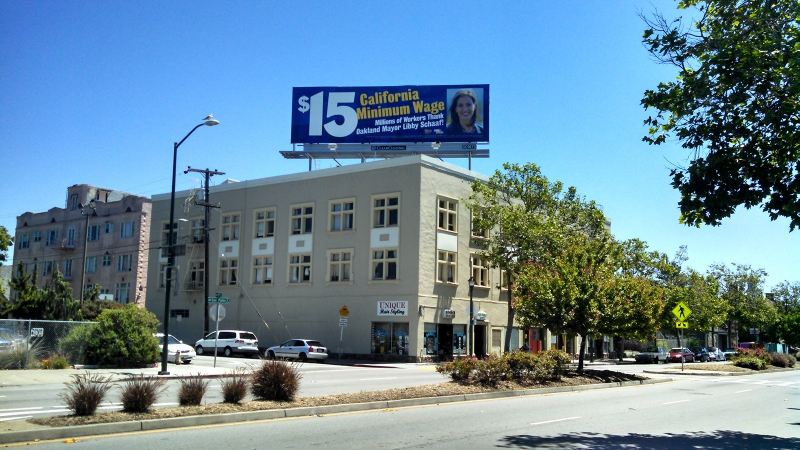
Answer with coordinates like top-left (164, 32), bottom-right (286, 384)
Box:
top-left (21, 371), bottom-right (800, 450)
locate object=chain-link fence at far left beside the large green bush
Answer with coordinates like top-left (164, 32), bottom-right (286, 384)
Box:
top-left (0, 319), bottom-right (96, 369)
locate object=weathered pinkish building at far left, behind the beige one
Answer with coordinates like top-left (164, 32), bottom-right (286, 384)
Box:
top-left (10, 184), bottom-right (152, 305)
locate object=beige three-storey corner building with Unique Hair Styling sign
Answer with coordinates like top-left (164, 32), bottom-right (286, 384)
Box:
top-left (146, 155), bottom-right (550, 361)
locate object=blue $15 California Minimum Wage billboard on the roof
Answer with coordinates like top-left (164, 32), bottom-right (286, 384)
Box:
top-left (292, 84), bottom-right (489, 144)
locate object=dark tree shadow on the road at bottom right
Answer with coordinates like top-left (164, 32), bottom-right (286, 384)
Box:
top-left (497, 430), bottom-right (800, 450)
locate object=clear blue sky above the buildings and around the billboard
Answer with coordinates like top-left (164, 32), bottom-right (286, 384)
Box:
top-left (0, 0), bottom-right (800, 287)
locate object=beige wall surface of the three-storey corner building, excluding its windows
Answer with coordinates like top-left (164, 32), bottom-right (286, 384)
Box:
top-left (146, 156), bottom-right (520, 357)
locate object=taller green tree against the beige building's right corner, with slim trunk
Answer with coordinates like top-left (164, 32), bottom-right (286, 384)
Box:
top-left (467, 163), bottom-right (605, 352)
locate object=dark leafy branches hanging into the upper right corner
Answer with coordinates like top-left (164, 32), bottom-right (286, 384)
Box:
top-left (639, 0), bottom-right (800, 230)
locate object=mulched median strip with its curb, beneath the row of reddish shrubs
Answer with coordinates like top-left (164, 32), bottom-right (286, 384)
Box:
top-left (0, 379), bottom-right (671, 444)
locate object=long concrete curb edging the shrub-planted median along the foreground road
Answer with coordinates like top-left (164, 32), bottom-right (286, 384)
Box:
top-left (0, 379), bottom-right (672, 444)
